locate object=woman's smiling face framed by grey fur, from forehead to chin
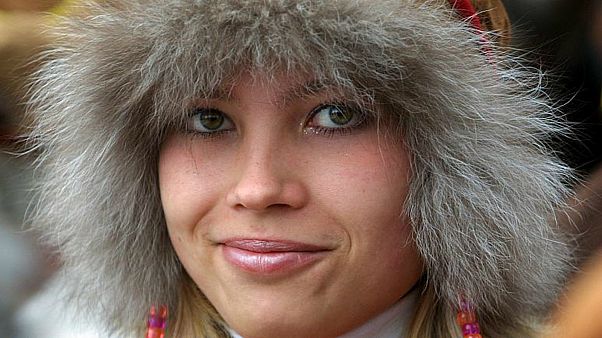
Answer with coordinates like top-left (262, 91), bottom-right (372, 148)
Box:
top-left (159, 74), bottom-right (422, 338)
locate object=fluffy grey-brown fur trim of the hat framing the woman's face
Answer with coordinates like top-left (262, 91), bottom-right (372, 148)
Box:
top-left (29, 0), bottom-right (570, 337)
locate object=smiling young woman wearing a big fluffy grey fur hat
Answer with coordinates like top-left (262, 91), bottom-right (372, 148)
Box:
top-left (31, 0), bottom-right (570, 338)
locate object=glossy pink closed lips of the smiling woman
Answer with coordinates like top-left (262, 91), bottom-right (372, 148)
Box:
top-left (222, 239), bottom-right (328, 274)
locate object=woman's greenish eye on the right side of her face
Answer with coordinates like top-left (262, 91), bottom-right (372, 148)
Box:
top-left (307, 104), bottom-right (366, 131)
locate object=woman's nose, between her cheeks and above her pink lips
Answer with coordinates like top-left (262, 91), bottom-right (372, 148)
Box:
top-left (226, 143), bottom-right (308, 211)
